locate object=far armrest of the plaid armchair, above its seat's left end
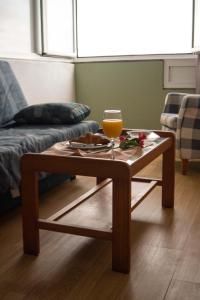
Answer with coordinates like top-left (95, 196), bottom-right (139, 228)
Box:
top-left (163, 93), bottom-right (187, 114)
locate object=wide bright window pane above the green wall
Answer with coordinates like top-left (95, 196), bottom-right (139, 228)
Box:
top-left (77, 0), bottom-right (193, 57)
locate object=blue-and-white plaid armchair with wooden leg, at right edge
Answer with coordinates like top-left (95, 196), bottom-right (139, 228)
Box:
top-left (160, 93), bottom-right (200, 175)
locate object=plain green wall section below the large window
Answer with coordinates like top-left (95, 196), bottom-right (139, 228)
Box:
top-left (75, 60), bottom-right (193, 129)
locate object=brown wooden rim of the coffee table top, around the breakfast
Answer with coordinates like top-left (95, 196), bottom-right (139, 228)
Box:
top-left (22, 131), bottom-right (174, 178)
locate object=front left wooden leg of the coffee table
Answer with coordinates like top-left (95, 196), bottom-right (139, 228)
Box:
top-left (22, 172), bottom-right (40, 255)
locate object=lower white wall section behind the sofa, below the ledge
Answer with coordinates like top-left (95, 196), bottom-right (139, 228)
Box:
top-left (6, 59), bottom-right (75, 104)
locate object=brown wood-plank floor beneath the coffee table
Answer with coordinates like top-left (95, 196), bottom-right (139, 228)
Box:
top-left (0, 159), bottom-right (200, 300)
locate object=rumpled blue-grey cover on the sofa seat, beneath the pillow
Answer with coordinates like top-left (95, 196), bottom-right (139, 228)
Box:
top-left (0, 121), bottom-right (99, 194)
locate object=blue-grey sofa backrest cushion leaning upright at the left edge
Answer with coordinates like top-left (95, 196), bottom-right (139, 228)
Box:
top-left (0, 61), bottom-right (28, 127)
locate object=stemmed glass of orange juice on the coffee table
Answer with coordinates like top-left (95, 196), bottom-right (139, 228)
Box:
top-left (102, 109), bottom-right (123, 159)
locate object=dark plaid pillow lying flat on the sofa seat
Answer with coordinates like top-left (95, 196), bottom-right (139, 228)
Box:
top-left (14, 102), bottom-right (90, 124)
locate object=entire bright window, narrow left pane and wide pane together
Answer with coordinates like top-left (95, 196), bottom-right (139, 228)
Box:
top-left (37, 0), bottom-right (200, 57)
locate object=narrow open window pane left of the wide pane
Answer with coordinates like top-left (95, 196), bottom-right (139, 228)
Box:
top-left (41, 0), bottom-right (76, 56)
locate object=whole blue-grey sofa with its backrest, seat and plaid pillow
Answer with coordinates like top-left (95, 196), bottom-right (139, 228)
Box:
top-left (0, 61), bottom-right (99, 212)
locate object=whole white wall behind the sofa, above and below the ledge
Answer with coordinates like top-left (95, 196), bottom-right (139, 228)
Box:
top-left (0, 0), bottom-right (75, 104)
